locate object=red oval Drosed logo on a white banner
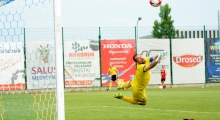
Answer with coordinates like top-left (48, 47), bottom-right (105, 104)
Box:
top-left (173, 54), bottom-right (203, 67)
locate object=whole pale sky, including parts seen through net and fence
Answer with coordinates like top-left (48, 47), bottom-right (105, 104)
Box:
top-left (0, 0), bottom-right (220, 39)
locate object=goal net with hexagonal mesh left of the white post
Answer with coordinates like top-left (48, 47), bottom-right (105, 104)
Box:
top-left (0, 0), bottom-right (63, 120)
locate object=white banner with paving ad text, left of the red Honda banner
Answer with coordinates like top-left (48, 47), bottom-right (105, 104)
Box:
top-left (64, 40), bottom-right (101, 87)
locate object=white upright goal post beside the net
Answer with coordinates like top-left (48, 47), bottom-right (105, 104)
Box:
top-left (54, 0), bottom-right (65, 120)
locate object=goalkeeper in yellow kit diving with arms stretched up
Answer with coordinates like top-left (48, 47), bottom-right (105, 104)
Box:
top-left (113, 51), bottom-right (167, 105)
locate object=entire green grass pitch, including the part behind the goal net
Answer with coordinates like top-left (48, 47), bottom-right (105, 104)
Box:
top-left (0, 87), bottom-right (220, 120)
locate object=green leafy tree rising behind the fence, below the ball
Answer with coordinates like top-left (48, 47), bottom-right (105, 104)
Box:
top-left (152, 4), bottom-right (178, 38)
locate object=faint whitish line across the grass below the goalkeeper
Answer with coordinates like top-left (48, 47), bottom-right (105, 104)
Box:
top-left (66, 106), bottom-right (220, 114)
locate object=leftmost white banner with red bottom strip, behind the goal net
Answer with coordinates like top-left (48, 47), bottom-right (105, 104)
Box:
top-left (0, 42), bottom-right (25, 90)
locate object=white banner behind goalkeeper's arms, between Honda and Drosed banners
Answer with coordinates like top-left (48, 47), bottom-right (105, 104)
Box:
top-left (137, 39), bottom-right (171, 84)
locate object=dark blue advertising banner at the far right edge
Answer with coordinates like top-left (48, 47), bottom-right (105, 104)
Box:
top-left (206, 38), bottom-right (220, 83)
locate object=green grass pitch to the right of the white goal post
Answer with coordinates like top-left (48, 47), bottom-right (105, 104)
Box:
top-left (65, 87), bottom-right (220, 120)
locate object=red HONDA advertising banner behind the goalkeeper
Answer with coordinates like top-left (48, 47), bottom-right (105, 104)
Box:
top-left (101, 39), bottom-right (136, 86)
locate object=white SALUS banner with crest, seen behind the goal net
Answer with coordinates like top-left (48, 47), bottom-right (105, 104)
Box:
top-left (26, 41), bottom-right (56, 89)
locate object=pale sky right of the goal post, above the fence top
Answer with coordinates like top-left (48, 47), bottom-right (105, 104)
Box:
top-left (61, 0), bottom-right (220, 28)
